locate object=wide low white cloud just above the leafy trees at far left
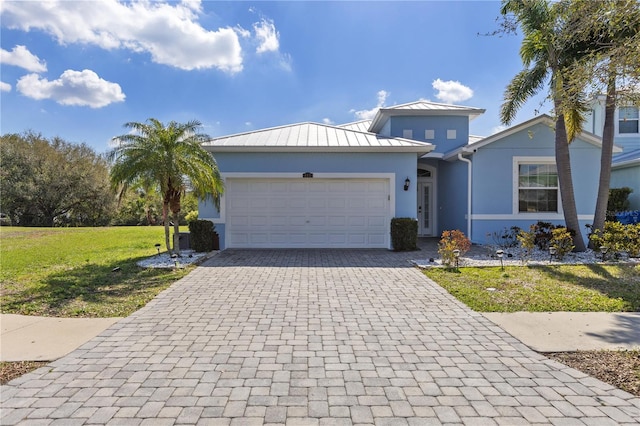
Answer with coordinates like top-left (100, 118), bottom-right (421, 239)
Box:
top-left (16, 70), bottom-right (125, 108)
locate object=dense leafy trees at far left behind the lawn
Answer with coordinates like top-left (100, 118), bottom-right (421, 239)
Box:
top-left (0, 132), bottom-right (115, 226)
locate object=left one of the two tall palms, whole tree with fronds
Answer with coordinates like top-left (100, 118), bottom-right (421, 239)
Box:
top-left (500, 0), bottom-right (586, 251)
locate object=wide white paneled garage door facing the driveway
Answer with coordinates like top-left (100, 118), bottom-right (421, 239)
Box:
top-left (225, 178), bottom-right (391, 248)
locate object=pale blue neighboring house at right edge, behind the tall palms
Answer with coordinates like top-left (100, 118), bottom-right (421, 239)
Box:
top-left (584, 95), bottom-right (640, 210)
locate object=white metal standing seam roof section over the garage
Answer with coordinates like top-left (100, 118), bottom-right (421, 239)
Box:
top-left (203, 123), bottom-right (434, 154)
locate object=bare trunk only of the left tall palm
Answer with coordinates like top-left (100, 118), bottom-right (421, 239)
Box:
top-left (555, 107), bottom-right (586, 251)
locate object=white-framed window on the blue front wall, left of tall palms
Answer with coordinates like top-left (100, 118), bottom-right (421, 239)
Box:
top-left (518, 163), bottom-right (558, 213)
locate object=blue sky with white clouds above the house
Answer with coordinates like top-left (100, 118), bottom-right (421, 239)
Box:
top-left (0, 0), bottom-right (550, 152)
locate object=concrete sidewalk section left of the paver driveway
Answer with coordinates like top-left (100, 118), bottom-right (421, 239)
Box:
top-left (0, 314), bottom-right (121, 361)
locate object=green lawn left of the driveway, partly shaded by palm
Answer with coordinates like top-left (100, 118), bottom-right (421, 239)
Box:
top-left (0, 227), bottom-right (191, 318)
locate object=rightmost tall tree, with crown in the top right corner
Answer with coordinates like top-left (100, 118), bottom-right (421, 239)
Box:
top-left (564, 0), bottom-right (640, 246)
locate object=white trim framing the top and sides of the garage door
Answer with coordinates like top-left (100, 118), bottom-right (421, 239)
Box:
top-left (212, 170), bottom-right (396, 230)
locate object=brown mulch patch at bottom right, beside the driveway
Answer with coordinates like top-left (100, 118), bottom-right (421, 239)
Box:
top-left (545, 350), bottom-right (640, 396)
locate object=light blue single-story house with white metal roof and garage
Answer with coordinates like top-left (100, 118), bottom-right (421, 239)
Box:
top-left (199, 101), bottom-right (616, 248)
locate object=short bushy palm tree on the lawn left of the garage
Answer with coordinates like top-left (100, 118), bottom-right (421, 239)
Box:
top-left (112, 118), bottom-right (224, 255)
